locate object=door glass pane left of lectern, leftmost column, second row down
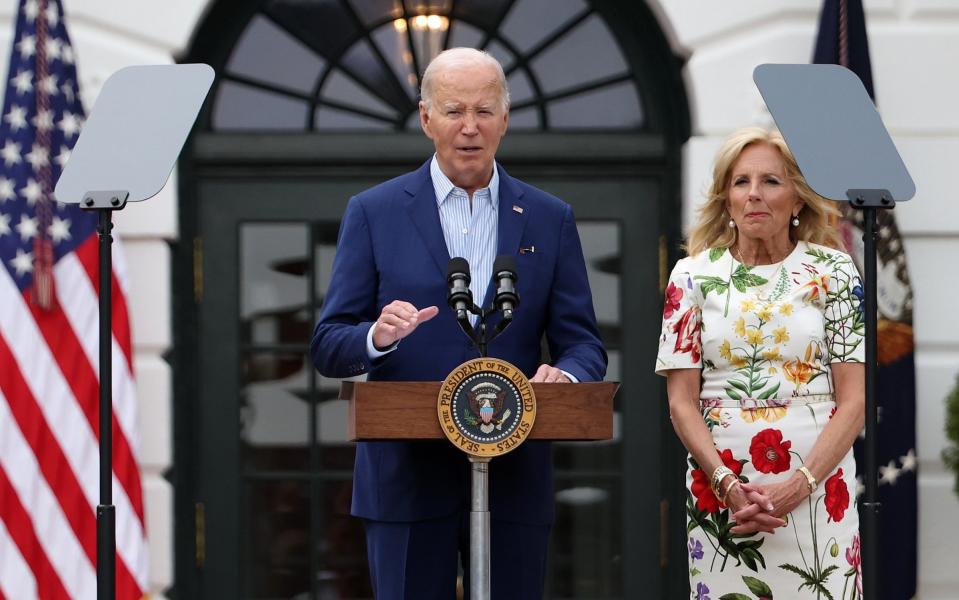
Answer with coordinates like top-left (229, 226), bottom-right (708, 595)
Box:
top-left (240, 352), bottom-right (313, 471)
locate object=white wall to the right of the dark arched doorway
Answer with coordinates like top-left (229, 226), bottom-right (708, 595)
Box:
top-left (656, 0), bottom-right (959, 600)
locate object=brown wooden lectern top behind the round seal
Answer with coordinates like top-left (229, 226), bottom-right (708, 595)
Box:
top-left (340, 381), bottom-right (619, 441)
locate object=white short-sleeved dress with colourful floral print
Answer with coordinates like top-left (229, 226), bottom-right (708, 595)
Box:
top-left (656, 242), bottom-right (865, 600)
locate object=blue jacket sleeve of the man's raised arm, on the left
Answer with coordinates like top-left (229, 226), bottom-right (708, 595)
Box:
top-left (310, 197), bottom-right (379, 378)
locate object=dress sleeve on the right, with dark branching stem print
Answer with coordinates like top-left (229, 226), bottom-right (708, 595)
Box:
top-left (823, 256), bottom-right (866, 362)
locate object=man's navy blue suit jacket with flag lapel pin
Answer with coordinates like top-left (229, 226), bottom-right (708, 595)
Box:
top-left (310, 161), bottom-right (606, 523)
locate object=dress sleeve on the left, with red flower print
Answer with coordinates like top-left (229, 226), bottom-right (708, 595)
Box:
top-left (656, 259), bottom-right (703, 375)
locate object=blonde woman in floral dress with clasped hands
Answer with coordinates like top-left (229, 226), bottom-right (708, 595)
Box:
top-left (656, 128), bottom-right (865, 600)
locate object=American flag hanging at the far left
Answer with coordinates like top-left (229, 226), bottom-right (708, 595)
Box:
top-left (0, 0), bottom-right (147, 600)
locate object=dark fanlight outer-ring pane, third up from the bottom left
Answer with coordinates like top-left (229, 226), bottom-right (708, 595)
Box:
top-left (264, 0), bottom-right (361, 59)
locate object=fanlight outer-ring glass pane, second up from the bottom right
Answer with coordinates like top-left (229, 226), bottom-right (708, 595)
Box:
top-left (532, 15), bottom-right (629, 95)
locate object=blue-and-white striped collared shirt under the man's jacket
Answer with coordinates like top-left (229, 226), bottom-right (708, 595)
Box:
top-left (430, 154), bottom-right (499, 325)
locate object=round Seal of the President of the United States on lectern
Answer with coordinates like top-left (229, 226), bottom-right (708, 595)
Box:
top-left (437, 358), bottom-right (536, 458)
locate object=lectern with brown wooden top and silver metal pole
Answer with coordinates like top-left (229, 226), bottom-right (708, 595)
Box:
top-left (340, 381), bottom-right (619, 600)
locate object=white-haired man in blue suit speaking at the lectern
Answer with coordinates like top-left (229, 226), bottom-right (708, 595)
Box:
top-left (311, 48), bottom-right (606, 600)
